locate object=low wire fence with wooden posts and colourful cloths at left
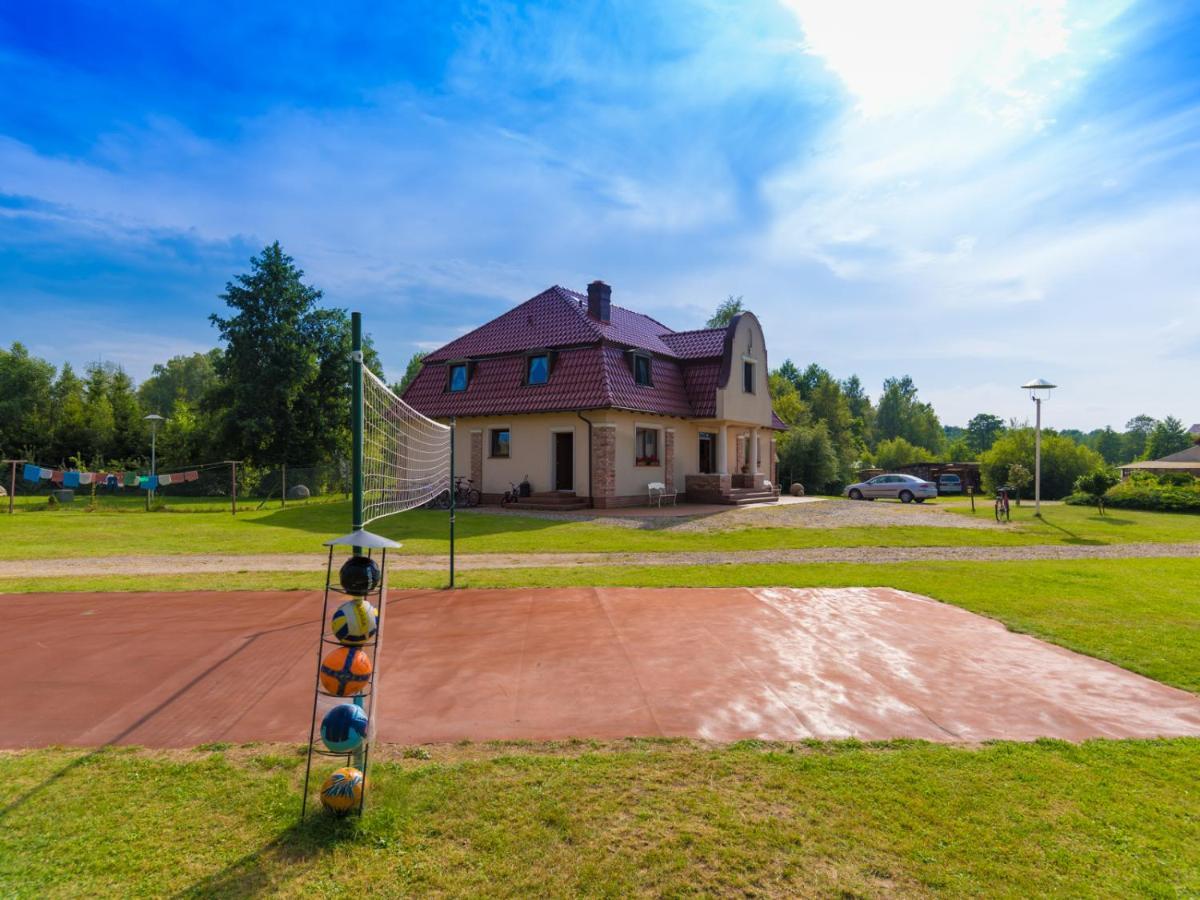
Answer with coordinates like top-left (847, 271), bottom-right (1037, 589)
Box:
top-left (0, 461), bottom-right (350, 515)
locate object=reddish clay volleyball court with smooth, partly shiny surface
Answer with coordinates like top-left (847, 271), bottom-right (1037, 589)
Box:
top-left (0, 588), bottom-right (1200, 748)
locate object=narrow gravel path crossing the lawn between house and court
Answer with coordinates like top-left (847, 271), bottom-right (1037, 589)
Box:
top-left (0, 544), bottom-right (1200, 578)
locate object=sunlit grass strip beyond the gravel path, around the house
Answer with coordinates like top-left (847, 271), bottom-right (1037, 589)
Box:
top-left (0, 499), bottom-right (1200, 559)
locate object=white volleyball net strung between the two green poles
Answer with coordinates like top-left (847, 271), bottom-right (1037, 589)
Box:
top-left (362, 366), bottom-right (450, 526)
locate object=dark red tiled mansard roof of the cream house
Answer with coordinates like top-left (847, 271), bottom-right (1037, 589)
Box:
top-left (404, 284), bottom-right (777, 418)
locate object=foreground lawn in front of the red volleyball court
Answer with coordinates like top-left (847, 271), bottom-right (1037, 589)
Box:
top-left (0, 740), bottom-right (1200, 898)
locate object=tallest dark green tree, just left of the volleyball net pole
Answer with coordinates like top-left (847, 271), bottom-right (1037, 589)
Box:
top-left (205, 241), bottom-right (379, 464)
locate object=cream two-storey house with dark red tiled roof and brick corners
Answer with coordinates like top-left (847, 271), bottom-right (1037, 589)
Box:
top-left (404, 281), bottom-right (782, 509)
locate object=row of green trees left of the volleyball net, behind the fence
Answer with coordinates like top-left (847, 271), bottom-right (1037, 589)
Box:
top-left (0, 242), bottom-right (383, 469)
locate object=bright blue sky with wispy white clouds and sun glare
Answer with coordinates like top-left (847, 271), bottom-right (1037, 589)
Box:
top-left (0, 0), bottom-right (1200, 428)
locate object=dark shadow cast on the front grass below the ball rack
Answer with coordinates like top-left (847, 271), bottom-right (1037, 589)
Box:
top-left (175, 815), bottom-right (362, 898)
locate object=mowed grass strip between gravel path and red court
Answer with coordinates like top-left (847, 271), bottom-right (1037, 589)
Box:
top-left (9, 558), bottom-right (1200, 692)
